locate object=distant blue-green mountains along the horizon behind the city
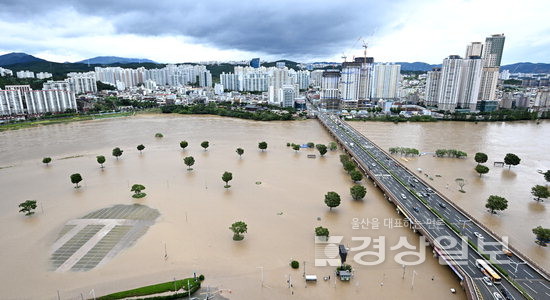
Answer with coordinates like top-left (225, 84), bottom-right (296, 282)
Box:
top-left (0, 52), bottom-right (550, 77)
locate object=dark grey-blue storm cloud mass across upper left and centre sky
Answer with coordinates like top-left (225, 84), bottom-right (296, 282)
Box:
top-left (0, 0), bottom-right (401, 57)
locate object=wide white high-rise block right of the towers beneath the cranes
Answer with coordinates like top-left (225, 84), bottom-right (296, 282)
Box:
top-left (371, 63), bottom-right (401, 99)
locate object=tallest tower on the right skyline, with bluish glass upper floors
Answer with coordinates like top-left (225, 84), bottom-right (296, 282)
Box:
top-left (478, 34), bottom-right (505, 101)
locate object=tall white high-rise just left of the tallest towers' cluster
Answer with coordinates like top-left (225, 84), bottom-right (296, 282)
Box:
top-left (437, 55), bottom-right (462, 111)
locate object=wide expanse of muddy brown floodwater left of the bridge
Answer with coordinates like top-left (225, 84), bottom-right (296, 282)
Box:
top-left (0, 115), bottom-right (466, 299)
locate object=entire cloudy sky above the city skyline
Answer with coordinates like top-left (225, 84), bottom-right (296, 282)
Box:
top-left (0, 0), bottom-right (550, 64)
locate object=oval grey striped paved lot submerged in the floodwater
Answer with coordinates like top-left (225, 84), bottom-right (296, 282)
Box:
top-left (50, 204), bottom-right (160, 272)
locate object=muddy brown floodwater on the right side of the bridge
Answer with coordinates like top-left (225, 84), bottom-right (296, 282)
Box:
top-left (350, 121), bottom-right (550, 271)
